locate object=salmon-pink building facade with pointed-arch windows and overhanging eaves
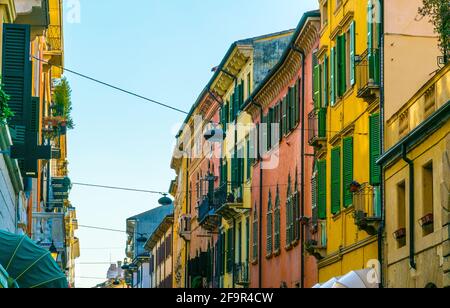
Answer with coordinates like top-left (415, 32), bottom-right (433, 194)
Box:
top-left (246, 11), bottom-right (320, 288)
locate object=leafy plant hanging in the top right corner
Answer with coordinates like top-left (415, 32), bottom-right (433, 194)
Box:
top-left (419, 0), bottom-right (450, 63)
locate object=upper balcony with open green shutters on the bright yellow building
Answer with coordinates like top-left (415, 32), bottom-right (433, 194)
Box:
top-left (355, 49), bottom-right (381, 103)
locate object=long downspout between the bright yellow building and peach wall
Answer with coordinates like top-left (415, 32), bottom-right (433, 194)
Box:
top-left (378, 0), bottom-right (386, 289)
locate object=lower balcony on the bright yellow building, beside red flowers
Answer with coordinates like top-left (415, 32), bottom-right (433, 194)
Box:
top-left (353, 183), bottom-right (381, 235)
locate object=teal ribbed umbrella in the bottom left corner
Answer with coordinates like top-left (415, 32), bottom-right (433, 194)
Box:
top-left (0, 231), bottom-right (68, 288)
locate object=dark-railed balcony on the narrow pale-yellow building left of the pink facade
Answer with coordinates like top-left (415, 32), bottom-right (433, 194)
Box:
top-left (214, 184), bottom-right (245, 220)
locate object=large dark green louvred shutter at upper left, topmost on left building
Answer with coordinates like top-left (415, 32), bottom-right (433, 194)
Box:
top-left (2, 24), bottom-right (32, 131)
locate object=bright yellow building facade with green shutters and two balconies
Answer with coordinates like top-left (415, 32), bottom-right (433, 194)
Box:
top-left (314, 0), bottom-right (381, 283)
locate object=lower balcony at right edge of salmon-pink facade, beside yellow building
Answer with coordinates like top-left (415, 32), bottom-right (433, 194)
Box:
top-left (305, 218), bottom-right (327, 261)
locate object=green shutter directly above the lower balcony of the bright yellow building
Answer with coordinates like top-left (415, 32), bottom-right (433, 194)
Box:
top-left (369, 114), bottom-right (381, 186)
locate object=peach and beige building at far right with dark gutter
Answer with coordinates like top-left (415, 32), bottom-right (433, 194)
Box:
top-left (379, 0), bottom-right (450, 288)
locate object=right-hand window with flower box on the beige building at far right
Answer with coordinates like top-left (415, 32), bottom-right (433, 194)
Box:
top-left (421, 162), bottom-right (434, 236)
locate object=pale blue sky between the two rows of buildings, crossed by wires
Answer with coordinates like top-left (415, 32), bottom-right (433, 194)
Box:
top-left (64, 0), bottom-right (318, 287)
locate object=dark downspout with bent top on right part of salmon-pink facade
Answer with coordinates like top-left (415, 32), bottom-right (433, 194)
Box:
top-left (291, 45), bottom-right (306, 289)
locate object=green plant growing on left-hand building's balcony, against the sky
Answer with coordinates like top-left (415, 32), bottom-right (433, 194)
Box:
top-left (52, 77), bottom-right (75, 129)
